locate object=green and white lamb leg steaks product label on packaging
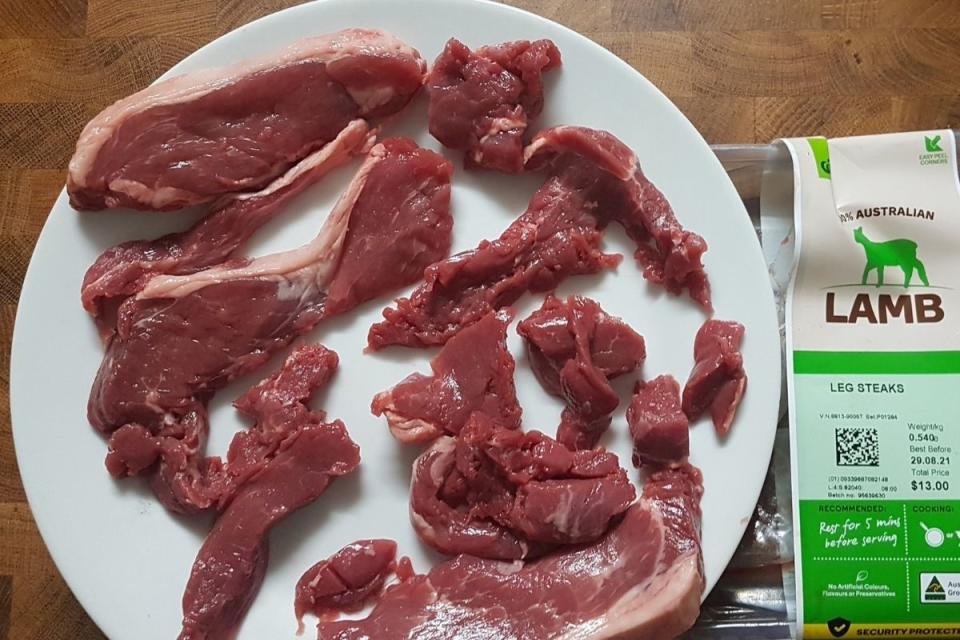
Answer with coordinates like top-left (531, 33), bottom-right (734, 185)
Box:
top-left (785, 131), bottom-right (960, 638)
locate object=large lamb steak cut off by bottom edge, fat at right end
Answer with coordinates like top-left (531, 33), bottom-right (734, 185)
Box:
top-left (318, 466), bottom-right (704, 640)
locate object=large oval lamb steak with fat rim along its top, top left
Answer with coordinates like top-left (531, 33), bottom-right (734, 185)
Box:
top-left (67, 29), bottom-right (426, 211)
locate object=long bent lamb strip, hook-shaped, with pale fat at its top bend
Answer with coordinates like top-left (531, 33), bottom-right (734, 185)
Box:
top-left (368, 126), bottom-right (712, 350)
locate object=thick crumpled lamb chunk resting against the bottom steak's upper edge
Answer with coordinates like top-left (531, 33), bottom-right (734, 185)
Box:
top-left (410, 413), bottom-right (636, 560)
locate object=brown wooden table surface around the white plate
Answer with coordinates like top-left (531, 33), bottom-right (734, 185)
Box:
top-left (0, 0), bottom-right (960, 640)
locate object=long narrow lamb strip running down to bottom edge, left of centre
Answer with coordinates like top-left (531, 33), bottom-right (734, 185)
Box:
top-left (180, 345), bottom-right (360, 640)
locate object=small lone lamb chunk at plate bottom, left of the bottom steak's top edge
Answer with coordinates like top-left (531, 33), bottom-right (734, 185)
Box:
top-left (294, 540), bottom-right (397, 632)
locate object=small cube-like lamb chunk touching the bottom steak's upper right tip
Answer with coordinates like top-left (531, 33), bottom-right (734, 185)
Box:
top-left (627, 376), bottom-right (690, 466)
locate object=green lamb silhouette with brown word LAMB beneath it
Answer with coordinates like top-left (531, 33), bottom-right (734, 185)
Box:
top-left (825, 227), bottom-right (944, 324)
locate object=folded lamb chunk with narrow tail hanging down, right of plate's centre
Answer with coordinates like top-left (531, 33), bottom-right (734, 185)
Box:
top-left (517, 296), bottom-right (647, 449)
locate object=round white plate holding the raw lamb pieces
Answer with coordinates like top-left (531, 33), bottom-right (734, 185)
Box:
top-left (11, 0), bottom-right (780, 640)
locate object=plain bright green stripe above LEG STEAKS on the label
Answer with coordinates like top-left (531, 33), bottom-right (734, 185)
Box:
top-left (793, 351), bottom-right (960, 374)
